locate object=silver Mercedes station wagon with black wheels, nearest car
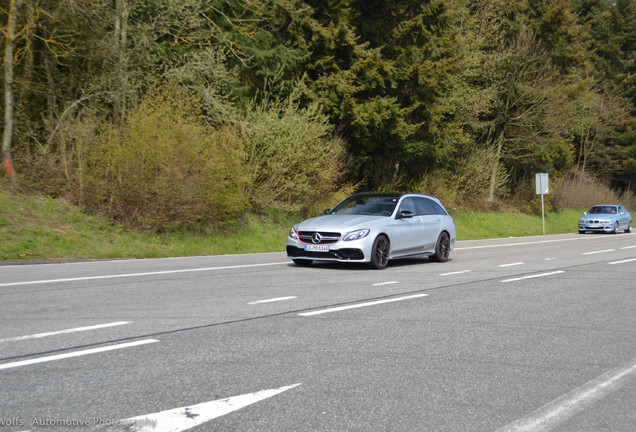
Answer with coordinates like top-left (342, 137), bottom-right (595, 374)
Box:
top-left (287, 193), bottom-right (457, 269)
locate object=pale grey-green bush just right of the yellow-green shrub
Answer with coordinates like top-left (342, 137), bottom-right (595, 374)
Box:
top-left (245, 96), bottom-right (351, 213)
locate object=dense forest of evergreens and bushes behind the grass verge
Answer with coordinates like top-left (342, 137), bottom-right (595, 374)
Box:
top-left (0, 0), bottom-right (636, 230)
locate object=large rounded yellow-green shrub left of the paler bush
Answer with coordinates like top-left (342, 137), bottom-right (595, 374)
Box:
top-left (83, 90), bottom-right (248, 230)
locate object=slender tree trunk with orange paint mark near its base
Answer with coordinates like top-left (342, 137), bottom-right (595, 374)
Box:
top-left (2, 0), bottom-right (22, 178)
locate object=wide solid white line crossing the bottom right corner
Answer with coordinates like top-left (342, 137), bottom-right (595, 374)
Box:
top-left (497, 358), bottom-right (636, 432)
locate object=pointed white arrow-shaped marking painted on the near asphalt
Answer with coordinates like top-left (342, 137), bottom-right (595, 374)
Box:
top-left (122, 383), bottom-right (300, 432)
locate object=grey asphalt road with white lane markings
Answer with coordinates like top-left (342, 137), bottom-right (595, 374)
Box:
top-left (0, 233), bottom-right (636, 432)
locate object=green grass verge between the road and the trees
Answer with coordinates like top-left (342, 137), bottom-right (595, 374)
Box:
top-left (0, 192), bottom-right (581, 261)
